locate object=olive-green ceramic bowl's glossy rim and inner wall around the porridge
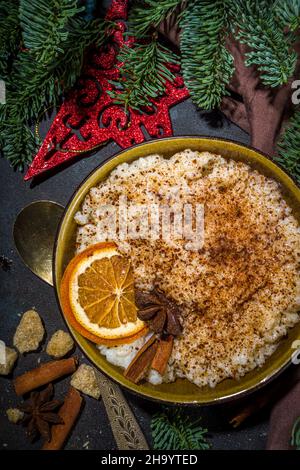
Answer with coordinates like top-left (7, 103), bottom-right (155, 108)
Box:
top-left (53, 137), bottom-right (300, 405)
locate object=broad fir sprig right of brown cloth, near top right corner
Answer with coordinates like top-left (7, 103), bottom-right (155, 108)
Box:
top-left (236, 0), bottom-right (297, 87)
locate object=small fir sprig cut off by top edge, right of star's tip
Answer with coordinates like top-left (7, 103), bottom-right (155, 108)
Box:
top-left (129, 0), bottom-right (186, 38)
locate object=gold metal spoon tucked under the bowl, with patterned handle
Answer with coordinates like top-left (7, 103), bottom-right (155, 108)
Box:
top-left (13, 201), bottom-right (149, 450)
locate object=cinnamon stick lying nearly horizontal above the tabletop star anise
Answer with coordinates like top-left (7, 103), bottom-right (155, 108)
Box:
top-left (14, 357), bottom-right (77, 395)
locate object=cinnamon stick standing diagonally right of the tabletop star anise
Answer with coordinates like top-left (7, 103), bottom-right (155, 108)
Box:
top-left (42, 387), bottom-right (83, 450)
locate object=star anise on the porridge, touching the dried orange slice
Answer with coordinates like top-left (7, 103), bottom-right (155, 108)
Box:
top-left (136, 288), bottom-right (182, 336)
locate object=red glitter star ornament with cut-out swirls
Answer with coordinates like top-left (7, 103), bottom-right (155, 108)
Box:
top-left (24, 0), bottom-right (189, 180)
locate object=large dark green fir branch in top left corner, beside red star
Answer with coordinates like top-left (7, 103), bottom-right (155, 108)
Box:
top-left (0, 0), bottom-right (107, 169)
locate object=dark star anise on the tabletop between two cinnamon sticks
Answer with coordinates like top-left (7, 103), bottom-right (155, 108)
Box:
top-left (19, 384), bottom-right (63, 442)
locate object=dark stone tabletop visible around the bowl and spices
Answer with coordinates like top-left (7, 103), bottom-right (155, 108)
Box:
top-left (0, 100), bottom-right (268, 450)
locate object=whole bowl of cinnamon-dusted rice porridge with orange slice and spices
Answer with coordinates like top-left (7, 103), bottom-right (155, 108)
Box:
top-left (53, 137), bottom-right (300, 404)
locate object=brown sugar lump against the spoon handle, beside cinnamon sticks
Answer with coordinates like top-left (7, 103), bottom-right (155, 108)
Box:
top-left (71, 364), bottom-right (101, 400)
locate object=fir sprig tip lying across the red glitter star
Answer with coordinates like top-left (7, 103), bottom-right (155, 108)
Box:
top-left (109, 36), bottom-right (178, 110)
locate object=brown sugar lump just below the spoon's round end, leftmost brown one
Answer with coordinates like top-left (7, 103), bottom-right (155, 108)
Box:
top-left (14, 310), bottom-right (45, 354)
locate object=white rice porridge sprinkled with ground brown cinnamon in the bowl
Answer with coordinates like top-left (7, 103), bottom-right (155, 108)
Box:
top-left (75, 150), bottom-right (300, 387)
